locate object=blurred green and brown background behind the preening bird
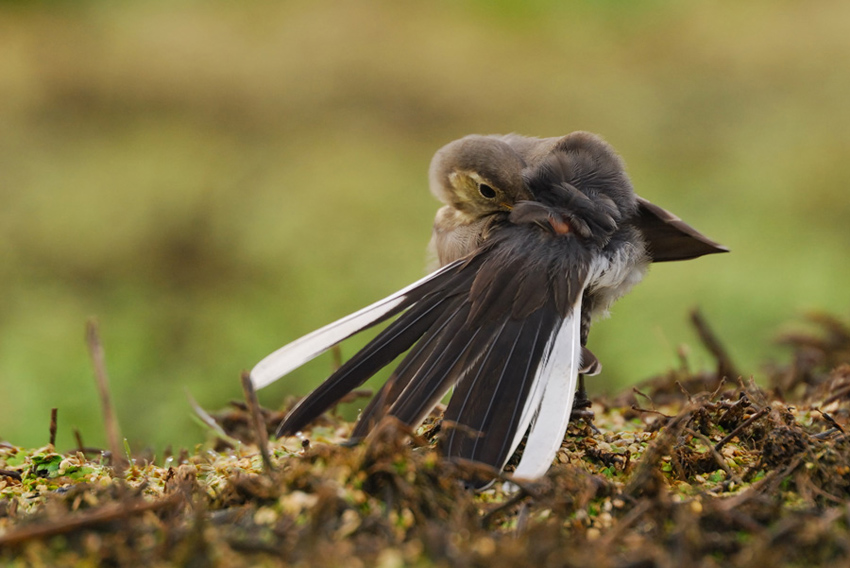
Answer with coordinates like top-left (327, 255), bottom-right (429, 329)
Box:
top-left (0, 0), bottom-right (850, 449)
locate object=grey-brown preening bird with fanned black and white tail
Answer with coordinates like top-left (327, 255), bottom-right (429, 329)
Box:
top-left (250, 131), bottom-right (728, 479)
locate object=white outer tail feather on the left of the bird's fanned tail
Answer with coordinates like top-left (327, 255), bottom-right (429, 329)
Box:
top-left (251, 261), bottom-right (462, 389)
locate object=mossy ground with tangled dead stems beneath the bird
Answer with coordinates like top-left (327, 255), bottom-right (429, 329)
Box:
top-left (0, 315), bottom-right (850, 568)
